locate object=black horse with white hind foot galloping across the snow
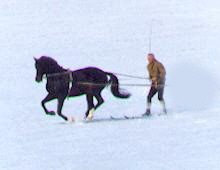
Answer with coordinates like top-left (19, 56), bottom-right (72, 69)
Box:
top-left (34, 56), bottom-right (130, 121)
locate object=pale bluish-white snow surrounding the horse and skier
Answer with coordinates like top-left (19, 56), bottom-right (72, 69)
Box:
top-left (0, 0), bottom-right (220, 170)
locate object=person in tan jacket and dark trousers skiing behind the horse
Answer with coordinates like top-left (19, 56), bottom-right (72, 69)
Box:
top-left (143, 53), bottom-right (167, 116)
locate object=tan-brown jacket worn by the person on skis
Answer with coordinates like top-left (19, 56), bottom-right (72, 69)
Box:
top-left (147, 60), bottom-right (166, 84)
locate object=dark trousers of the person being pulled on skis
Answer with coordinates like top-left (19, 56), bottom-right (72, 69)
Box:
top-left (147, 85), bottom-right (164, 104)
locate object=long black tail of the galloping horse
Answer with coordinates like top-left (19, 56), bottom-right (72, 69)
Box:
top-left (106, 72), bottom-right (131, 99)
